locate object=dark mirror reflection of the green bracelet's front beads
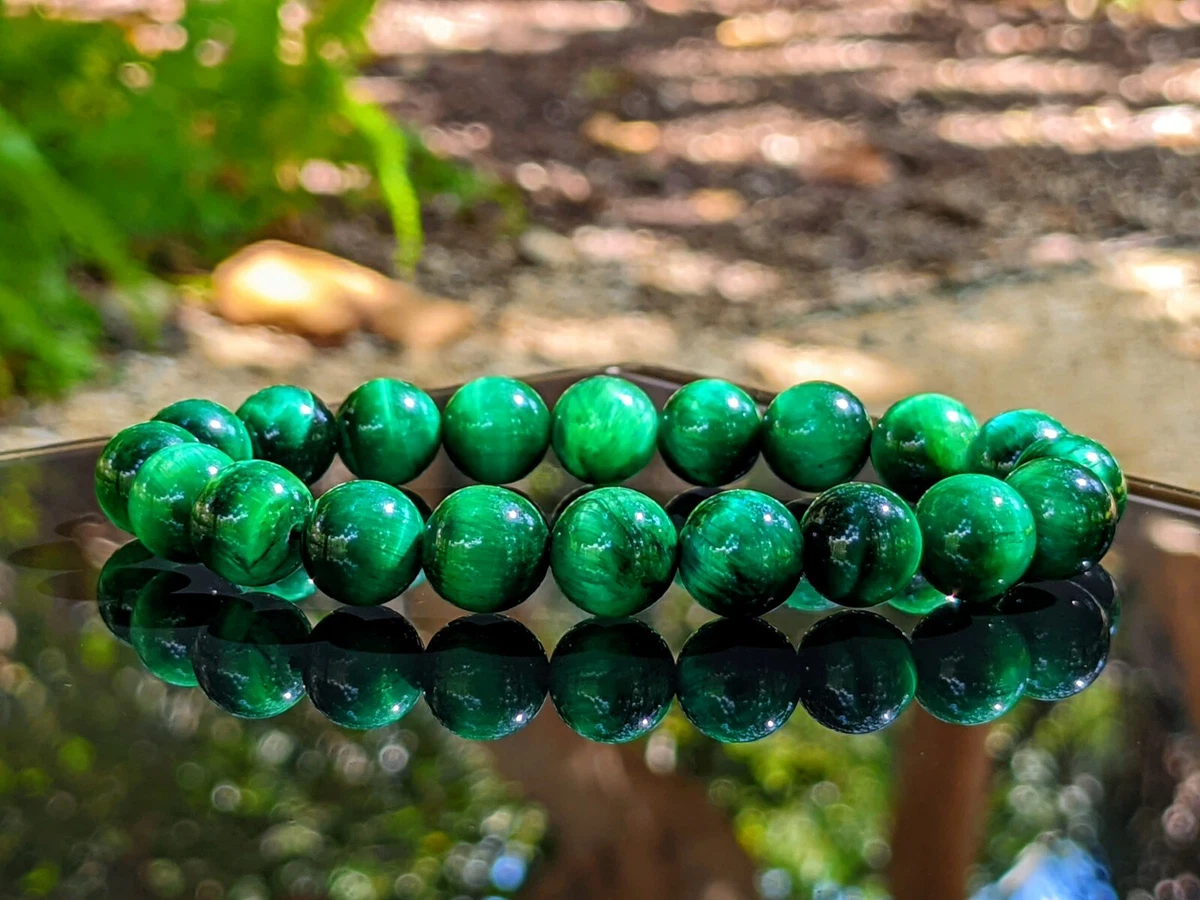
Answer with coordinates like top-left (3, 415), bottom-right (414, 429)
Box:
top-left (96, 542), bottom-right (1120, 743)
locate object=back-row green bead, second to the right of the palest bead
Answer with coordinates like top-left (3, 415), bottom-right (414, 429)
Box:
top-left (762, 382), bottom-right (871, 491)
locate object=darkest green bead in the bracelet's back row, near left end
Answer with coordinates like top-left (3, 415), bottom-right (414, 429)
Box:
top-left (238, 384), bottom-right (337, 485)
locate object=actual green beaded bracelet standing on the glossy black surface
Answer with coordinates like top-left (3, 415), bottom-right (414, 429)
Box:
top-left (96, 376), bottom-right (1126, 616)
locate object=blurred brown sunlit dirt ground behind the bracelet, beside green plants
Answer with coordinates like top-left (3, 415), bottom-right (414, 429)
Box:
top-left (0, 0), bottom-right (1200, 488)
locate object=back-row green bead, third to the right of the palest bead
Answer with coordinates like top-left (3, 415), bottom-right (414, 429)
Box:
top-left (871, 394), bottom-right (979, 500)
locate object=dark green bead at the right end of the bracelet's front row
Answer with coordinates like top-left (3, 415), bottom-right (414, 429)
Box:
top-left (1004, 460), bottom-right (1117, 580)
